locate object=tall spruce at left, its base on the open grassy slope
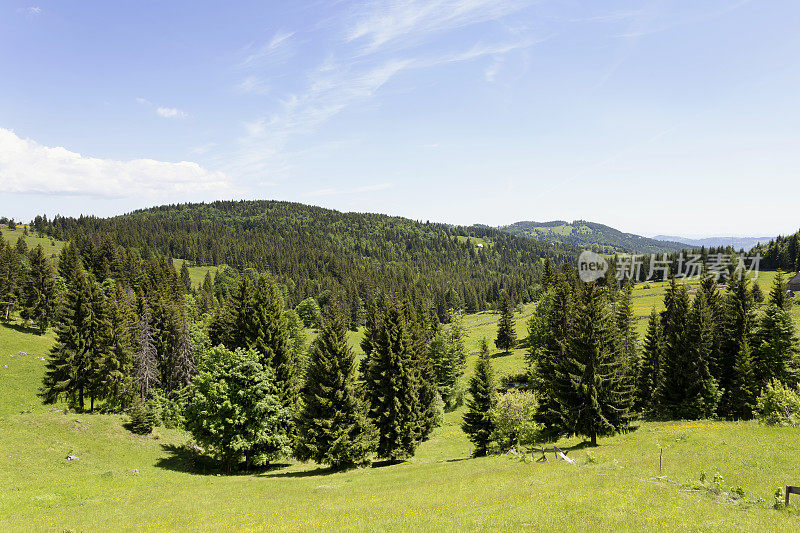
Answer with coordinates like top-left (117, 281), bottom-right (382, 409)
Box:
top-left (41, 267), bottom-right (93, 411)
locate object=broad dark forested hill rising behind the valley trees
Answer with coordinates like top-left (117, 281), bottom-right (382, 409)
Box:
top-left (46, 201), bottom-right (578, 310)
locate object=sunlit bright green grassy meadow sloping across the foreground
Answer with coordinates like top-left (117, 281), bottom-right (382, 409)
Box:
top-left (0, 294), bottom-right (800, 531)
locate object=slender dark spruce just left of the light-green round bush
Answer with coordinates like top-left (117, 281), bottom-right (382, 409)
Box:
top-left (461, 339), bottom-right (497, 457)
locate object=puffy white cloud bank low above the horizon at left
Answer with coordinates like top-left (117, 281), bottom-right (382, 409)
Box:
top-left (0, 128), bottom-right (234, 201)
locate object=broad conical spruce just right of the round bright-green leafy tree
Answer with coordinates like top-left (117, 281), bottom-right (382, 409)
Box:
top-left (295, 318), bottom-right (373, 468)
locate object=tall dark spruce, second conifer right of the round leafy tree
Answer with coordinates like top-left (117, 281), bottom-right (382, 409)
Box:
top-left (366, 302), bottom-right (421, 461)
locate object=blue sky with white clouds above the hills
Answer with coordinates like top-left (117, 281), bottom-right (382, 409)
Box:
top-left (0, 0), bottom-right (800, 236)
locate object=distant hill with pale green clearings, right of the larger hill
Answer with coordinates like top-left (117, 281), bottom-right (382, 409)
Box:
top-left (498, 220), bottom-right (691, 254)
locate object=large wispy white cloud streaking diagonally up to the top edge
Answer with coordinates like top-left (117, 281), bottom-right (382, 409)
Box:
top-left (230, 0), bottom-right (541, 179)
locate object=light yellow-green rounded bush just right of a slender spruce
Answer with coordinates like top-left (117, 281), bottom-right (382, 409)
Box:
top-left (491, 391), bottom-right (543, 451)
